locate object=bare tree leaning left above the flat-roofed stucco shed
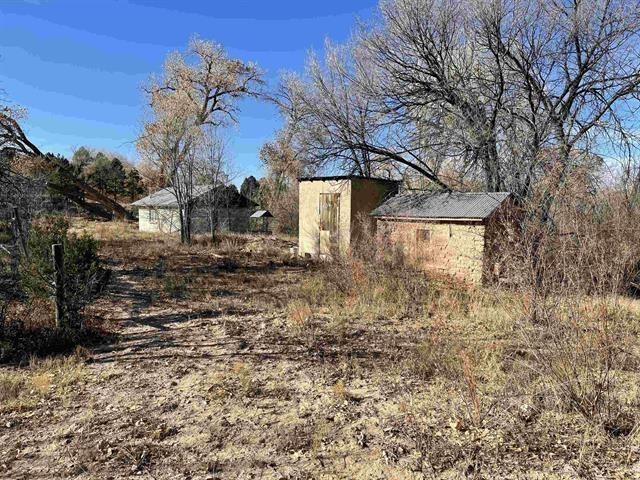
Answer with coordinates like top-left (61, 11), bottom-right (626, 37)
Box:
top-left (279, 43), bottom-right (446, 188)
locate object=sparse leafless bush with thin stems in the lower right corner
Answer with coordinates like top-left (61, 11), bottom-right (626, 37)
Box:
top-left (521, 296), bottom-right (640, 430)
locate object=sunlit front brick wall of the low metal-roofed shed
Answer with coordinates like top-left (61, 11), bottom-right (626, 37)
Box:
top-left (377, 219), bottom-right (485, 283)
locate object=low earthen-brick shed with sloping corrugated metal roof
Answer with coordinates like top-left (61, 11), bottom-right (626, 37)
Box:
top-left (371, 192), bottom-right (512, 283)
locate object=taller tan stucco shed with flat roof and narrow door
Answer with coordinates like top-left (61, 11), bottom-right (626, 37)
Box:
top-left (298, 175), bottom-right (398, 257)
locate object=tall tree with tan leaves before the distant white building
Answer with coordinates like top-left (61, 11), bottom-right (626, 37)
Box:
top-left (138, 38), bottom-right (261, 243)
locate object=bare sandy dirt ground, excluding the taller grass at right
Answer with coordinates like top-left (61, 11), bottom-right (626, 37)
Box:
top-left (0, 219), bottom-right (640, 479)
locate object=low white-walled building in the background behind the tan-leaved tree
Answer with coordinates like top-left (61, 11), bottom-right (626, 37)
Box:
top-left (131, 185), bottom-right (257, 234)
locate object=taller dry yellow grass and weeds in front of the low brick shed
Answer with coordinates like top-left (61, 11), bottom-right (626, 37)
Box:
top-left (289, 242), bottom-right (640, 470)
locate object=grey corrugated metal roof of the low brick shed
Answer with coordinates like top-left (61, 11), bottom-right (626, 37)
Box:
top-left (371, 192), bottom-right (511, 220)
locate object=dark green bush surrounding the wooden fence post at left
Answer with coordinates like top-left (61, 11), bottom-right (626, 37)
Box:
top-left (0, 217), bottom-right (107, 361)
